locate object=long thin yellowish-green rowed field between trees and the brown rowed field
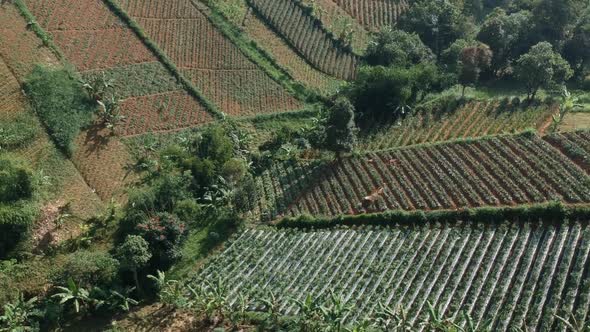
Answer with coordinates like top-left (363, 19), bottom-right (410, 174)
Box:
top-left (359, 100), bottom-right (556, 151)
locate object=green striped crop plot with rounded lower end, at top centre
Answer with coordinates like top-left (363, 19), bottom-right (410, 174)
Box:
top-left (248, 0), bottom-right (359, 80)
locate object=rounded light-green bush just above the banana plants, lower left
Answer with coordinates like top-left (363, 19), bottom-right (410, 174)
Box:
top-left (51, 250), bottom-right (119, 288)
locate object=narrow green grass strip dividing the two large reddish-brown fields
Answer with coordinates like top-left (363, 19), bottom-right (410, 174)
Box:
top-left (104, 0), bottom-right (224, 119)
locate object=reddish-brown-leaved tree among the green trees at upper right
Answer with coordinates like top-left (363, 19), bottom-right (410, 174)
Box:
top-left (459, 44), bottom-right (493, 96)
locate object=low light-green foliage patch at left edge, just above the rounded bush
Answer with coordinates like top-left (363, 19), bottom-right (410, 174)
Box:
top-left (0, 113), bottom-right (39, 151)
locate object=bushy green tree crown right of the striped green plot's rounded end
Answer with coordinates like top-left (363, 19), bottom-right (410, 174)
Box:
top-left (365, 27), bottom-right (434, 66)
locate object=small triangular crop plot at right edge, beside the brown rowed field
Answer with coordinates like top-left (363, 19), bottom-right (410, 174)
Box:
top-left (545, 130), bottom-right (590, 171)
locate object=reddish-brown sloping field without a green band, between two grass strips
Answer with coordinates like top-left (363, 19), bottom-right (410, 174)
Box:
top-left (120, 0), bottom-right (301, 116)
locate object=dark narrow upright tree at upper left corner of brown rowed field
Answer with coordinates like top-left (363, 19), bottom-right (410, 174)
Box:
top-left (325, 97), bottom-right (358, 157)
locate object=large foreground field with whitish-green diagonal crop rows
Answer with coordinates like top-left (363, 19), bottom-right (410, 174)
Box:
top-left (200, 220), bottom-right (590, 331)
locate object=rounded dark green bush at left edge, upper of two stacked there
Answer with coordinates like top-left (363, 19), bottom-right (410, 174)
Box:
top-left (0, 155), bottom-right (33, 203)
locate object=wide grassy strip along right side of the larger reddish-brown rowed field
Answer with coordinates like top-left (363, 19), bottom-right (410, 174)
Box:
top-left (198, 0), bottom-right (320, 101)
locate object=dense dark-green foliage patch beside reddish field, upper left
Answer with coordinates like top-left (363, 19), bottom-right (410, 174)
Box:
top-left (25, 66), bottom-right (95, 155)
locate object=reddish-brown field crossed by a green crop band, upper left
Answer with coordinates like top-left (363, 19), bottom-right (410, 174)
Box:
top-left (25, 0), bottom-right (213, 136)
